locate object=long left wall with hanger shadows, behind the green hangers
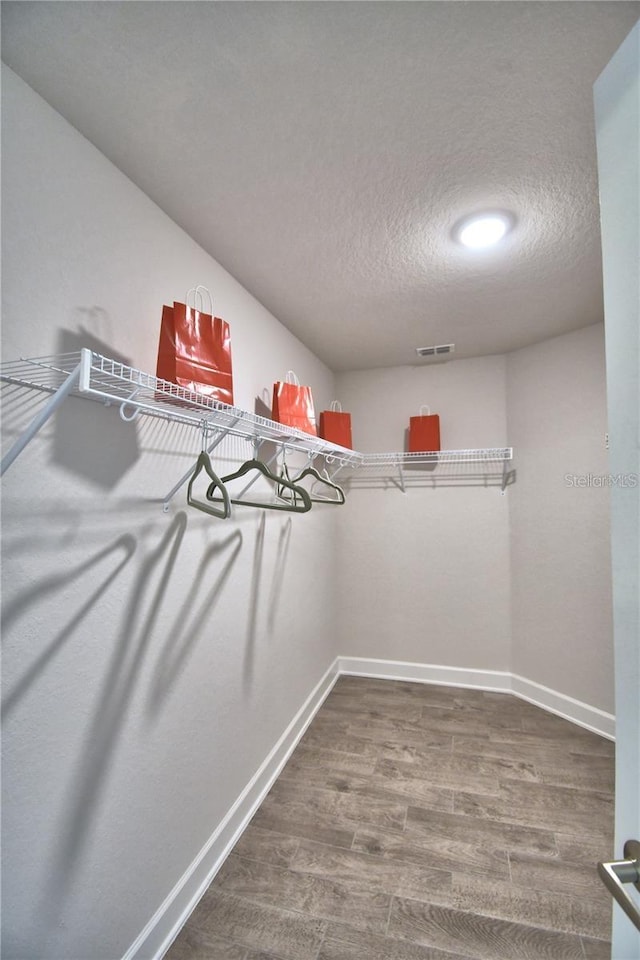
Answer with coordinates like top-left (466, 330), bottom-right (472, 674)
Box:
top-left (2, 70), bottom-right (337, 960)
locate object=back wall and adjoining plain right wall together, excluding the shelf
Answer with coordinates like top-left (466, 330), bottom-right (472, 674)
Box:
top-left (336, 325), bottom-right (613, 712)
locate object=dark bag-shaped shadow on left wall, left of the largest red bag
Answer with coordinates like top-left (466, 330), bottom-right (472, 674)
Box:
top-left (52, 324), bottom-right (140, 490)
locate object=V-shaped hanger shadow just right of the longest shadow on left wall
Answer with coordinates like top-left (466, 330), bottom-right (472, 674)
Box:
top-left (148, 530), bottom-right (242, 716)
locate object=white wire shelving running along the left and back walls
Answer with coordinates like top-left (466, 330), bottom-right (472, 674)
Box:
top-left (0, 348), bottom-right (513, 496)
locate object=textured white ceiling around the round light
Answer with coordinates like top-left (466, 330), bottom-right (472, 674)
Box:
top-left (2, 0), bottom-right (640, 370)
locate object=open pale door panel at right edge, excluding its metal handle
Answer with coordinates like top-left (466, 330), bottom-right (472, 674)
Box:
top-left (594, 18), bottom-right (640, 960)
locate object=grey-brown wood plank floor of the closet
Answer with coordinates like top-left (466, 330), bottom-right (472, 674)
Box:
top-left (167, 677), bottom-right (614, 960)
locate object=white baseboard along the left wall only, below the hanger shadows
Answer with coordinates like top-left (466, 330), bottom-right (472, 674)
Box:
top-left (122, 660), bottom-right (339, 960)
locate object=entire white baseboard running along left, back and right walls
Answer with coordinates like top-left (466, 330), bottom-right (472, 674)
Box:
top-left (122, 657), bottom-right (615, 960)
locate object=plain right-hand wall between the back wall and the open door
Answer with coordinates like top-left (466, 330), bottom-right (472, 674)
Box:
top-left (507, 324), bottom-right (614, 713)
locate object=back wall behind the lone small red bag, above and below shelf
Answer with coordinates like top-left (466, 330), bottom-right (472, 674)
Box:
top-left (336, 357), bottom-right (510, 670)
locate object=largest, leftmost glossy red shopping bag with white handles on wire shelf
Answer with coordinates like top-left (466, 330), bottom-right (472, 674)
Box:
top-left (156, 287), bottom-right (233, 405)
